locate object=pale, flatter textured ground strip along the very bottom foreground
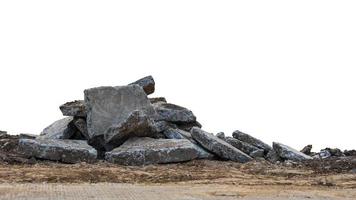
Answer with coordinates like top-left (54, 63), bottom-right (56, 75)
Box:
top-left (0, 183), bottom-right (356, 200)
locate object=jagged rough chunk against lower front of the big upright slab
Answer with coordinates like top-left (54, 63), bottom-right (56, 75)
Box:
top-left (104, 110), bottom-right (155, 150)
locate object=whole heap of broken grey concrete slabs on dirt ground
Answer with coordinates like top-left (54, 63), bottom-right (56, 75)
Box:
top-left (19, 76), bottom-right (355, 165)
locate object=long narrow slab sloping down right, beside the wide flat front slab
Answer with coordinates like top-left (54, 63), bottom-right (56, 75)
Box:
top-left (191, 127), bottom-right (252, 163)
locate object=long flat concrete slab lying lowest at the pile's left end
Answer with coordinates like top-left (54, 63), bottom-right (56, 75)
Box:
top-left (19, 139), bottom-right (97, 163)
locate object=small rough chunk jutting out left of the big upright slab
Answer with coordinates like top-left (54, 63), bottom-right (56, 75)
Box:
top-left (59, 100), bottom-right (87, 117)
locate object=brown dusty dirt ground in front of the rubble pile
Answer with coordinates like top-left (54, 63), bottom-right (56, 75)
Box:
top-left (0, 133), bottom-right (356, 200)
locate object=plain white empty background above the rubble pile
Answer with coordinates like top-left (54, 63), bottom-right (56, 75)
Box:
top-left (0, 0), bottom-right (356, 150)
